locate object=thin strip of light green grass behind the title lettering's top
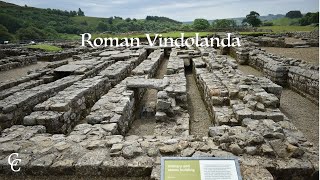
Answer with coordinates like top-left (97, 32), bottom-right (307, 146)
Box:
top-left (92, 31), bottom-right (213, 38)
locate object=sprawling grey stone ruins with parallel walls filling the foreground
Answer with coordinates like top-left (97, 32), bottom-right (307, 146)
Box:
top-left (0, 38), bottom-right (319, 179)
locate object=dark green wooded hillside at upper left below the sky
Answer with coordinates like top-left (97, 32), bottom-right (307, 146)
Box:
top-left (0, 1), bottom-right (182, 41)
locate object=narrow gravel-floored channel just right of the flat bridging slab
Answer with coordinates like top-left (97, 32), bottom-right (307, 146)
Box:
top-left (186, 73), bottom-right (212, 136)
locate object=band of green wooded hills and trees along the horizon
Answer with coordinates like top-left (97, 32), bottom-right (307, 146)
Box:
top-left (0, 0), bottom-right (319, 41)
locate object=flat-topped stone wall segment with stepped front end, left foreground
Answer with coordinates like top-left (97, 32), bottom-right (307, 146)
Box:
top-left (23, 77), bottom-right (111, 134)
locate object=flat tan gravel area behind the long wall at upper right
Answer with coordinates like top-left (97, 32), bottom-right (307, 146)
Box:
top-left (262, 47), bottom-right (319, 65)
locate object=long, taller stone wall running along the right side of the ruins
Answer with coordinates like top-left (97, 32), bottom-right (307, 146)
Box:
top-left (231, 40), bottom-right (319, 102)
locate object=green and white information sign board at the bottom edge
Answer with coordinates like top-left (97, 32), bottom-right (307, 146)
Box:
top-left (161, 157), bottom-right (242, 180)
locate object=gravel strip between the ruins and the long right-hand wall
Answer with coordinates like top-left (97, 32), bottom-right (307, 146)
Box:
top-left (239, 65), bottom-right (319, 147)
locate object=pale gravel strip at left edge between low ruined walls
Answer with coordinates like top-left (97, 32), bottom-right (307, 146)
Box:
top-left (0, 61), bottom-right (48, 82)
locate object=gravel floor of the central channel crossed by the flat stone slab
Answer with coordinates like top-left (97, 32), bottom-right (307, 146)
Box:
top-left (128, 58), bottom-right (169, 136)
